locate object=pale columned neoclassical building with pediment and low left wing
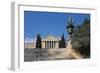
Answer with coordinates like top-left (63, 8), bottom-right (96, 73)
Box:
top-left (24, 35), bottom-right (61, 48)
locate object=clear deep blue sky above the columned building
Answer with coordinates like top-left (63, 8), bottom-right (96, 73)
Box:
top-left (24, 11), bottom-right (90, 42)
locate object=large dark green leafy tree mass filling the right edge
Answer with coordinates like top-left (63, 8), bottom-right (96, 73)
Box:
top-left (71, 19), bottom-right (90, 58)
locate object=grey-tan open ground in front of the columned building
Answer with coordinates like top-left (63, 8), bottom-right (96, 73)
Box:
top-left (24, 48), bottom-right (73, 62)
